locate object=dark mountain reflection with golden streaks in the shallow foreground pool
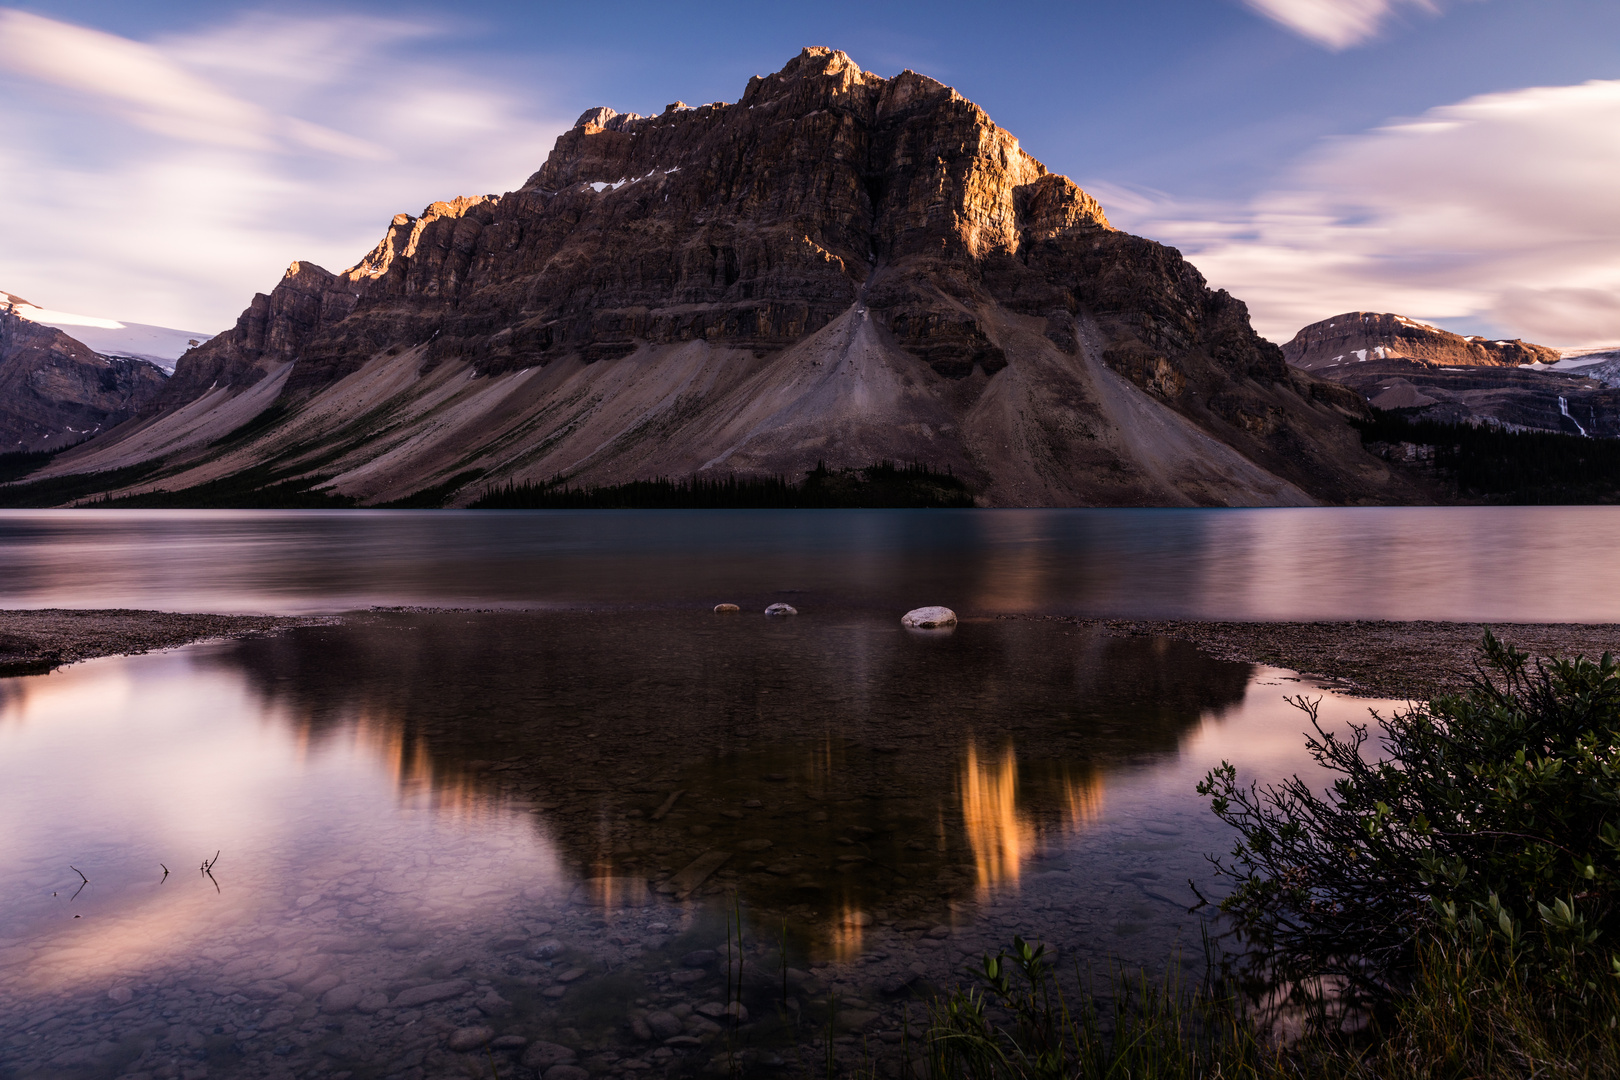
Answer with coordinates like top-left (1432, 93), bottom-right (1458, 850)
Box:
top-left (212, 612), bottom-right (1249, 925)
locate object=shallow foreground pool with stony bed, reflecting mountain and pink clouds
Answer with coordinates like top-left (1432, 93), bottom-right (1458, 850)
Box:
top-left (0, 604), bottom-right (1364, 1080)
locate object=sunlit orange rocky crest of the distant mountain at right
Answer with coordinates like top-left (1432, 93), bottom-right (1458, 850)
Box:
top-left (1283, 311), bottom-right (1560, 371)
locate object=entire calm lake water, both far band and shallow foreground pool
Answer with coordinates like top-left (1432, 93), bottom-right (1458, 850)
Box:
top-left (0, 510), bottom-right (1620, 1080)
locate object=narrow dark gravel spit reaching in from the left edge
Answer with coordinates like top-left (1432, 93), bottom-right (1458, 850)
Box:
top-left (0, 609), bottom-right (337, 675)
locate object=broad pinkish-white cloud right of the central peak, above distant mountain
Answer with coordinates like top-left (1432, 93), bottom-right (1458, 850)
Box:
top-left (1094, 81), bottom-right (1620, 347)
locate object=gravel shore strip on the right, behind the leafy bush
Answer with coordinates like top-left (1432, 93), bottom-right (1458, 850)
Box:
top-left (1063, 619), bottom-right (1620, 699)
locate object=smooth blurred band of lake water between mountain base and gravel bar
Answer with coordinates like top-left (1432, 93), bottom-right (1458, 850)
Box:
top-left (0, 507), bottom-right (1620, 622)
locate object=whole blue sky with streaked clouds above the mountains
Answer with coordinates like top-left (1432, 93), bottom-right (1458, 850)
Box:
top-left (0, 0), bottom-right (1620, 348)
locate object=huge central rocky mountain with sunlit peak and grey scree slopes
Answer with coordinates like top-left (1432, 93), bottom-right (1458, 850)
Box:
top-left (25, 49), bottom-right (1421, 505)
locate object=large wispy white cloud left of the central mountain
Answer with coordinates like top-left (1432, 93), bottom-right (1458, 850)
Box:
top-left (0, 8), bottom-right (567, 330)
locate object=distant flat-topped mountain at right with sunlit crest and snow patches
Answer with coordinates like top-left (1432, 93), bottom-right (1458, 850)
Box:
top-left (1283, 311), bottom-right (1620, 437)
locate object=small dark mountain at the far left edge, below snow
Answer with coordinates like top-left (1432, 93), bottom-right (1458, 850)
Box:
top-left (0, 293), bottom-right (167, 453)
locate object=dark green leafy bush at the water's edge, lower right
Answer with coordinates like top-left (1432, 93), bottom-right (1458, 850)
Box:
top-left (1199, 633), bottom-right (1620, 993)
